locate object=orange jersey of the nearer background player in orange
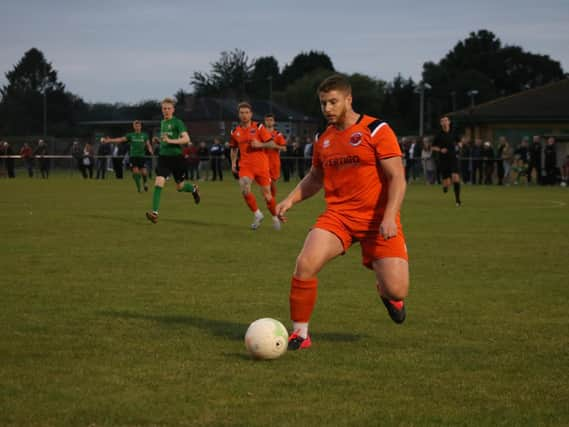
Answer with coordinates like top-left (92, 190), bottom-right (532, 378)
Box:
top-left (229, 122), bottom-right (272, 169)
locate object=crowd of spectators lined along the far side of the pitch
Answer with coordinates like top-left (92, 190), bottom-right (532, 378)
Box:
top-left (0, 136), bottom-right (569, 186)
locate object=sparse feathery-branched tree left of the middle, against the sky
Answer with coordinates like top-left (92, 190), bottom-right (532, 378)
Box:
top-left (190, 49), bottom-right (253, 98)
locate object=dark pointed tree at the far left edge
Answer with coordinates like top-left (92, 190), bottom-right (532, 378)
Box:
top-left (0, 48), bottom-right (85, 135)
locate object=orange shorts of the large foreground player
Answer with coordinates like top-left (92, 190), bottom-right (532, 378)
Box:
top-left (314, 211), bottom-right (409, 269)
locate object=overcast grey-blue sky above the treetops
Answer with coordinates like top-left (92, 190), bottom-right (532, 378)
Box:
top-left (0, 0), bottom-right (569, 103)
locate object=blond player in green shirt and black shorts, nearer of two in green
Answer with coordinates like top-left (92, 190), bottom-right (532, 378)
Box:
top-left (146, 98), bottom-right (200, 224)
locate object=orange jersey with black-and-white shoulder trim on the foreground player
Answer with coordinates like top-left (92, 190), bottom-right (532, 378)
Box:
top-left (312, 115), bottom-right (401, 221)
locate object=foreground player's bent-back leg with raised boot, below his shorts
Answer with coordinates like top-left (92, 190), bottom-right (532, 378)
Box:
top-left (373, 257), bottom-right (409, 324)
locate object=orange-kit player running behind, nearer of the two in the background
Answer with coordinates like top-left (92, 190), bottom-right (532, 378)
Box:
top-left (229, 102), bottom-right (281, 230)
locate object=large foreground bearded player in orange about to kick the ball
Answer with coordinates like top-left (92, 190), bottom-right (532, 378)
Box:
top-left (277, 74), bottom-right (409, 350)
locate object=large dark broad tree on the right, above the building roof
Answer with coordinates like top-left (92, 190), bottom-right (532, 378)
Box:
top-left (423, 30), bottom-right (564, 115)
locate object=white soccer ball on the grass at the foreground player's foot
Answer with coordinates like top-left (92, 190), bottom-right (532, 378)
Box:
top-left (245, 318), bottom-right (288, 359)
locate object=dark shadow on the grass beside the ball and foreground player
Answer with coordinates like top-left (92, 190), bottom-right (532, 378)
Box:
top-left (100, 311), bottom-right (369, 343)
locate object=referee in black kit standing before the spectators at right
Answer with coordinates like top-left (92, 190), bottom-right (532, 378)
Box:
top-left (433, 116), bottom-right (461, 207)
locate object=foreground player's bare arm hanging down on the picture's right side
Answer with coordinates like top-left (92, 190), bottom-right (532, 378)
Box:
top-left (379, 156), bottom-right (407, 239)
